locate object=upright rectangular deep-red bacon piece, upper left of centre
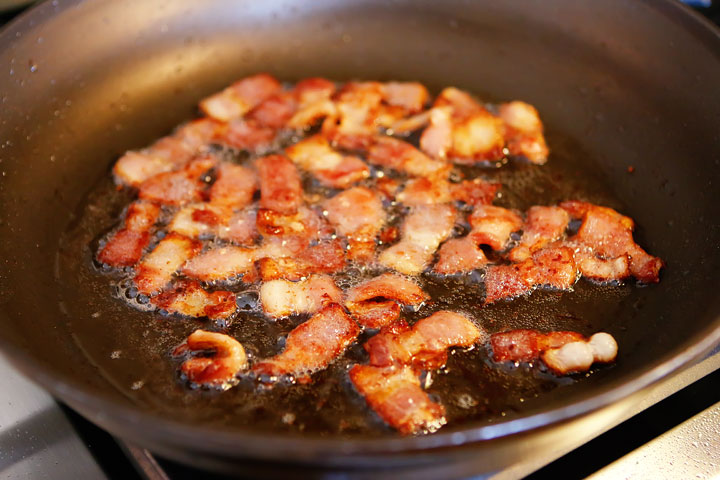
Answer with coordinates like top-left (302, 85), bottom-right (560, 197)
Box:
top-left (256, 155), bottom-right (302, 214)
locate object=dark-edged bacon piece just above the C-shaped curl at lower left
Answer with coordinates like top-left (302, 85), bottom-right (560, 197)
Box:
top-left (150, 280), bottom-right (237, 320)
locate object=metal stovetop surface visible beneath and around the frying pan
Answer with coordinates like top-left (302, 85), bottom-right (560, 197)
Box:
top-left (0, 0), bottom-right (720, 480)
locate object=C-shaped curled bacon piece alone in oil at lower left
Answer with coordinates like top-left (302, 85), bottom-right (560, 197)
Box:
top-left (173, 330), bottom-right (248, 390)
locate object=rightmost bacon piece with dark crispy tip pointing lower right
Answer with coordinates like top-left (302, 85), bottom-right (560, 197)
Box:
top-left (560, 201), bottom-right (663, 283)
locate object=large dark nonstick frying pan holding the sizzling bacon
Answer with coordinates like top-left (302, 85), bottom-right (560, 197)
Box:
top-left (0, 0), bottom-right (720, 476)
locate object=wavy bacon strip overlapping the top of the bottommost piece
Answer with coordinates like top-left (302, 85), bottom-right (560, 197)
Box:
top-left (364, 310), bottom-right (484, 368)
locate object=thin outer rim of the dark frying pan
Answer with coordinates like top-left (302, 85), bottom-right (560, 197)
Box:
top-left (0, 0), bottom-right (720, 457)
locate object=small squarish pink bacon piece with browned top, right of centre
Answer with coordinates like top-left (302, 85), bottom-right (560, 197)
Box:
top-left (469, 205), bottom-right (522, 250)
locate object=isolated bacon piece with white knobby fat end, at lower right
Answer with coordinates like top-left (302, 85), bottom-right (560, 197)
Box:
top-left (490, 330), bottom-right (618, 375)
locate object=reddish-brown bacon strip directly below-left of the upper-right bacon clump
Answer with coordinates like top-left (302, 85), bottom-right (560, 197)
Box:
top-left (367, 137), bottom-right (448, 177)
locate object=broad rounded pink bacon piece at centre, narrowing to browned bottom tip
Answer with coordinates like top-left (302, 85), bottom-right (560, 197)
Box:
top-left (324, 187), bottom-right (386, 261)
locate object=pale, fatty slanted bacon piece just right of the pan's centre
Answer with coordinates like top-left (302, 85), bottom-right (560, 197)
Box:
top-left (378, 204), bottom-right (455, 275)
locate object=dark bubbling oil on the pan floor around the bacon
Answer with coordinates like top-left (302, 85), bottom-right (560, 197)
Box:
top-left (56, 123), bottom-right (636, 436)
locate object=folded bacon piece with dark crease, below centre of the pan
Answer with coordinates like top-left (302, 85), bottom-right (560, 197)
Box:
top-left (345, 273), bottom-right (429, 328)
